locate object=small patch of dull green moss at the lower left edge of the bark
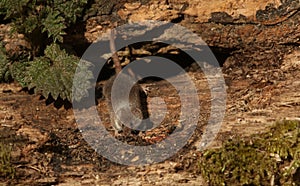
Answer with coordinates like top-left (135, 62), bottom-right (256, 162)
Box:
top-left (0, 143), bottom-right (15, 178)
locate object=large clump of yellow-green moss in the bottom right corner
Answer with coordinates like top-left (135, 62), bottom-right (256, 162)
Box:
top-left (200, 121), bottom-right (300, 185)
